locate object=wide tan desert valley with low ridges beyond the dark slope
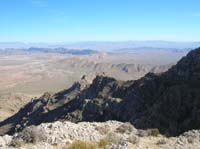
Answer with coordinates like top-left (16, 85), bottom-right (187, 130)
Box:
top-left (0, 44), bottom-right (189, 119)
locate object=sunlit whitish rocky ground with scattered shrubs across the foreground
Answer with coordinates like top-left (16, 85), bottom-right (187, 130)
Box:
top-left (0, 121), bottom-right (200, 149)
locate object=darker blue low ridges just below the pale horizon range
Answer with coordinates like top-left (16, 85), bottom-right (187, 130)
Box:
top-left (0, 47), bottom-right (191, 55)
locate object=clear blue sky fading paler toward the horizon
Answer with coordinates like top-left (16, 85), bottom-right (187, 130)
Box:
top-left (0, 0), bottom-right (200, 42)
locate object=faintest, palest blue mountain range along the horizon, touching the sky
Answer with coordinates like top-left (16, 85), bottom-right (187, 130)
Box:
top-left (0, 41), bottom-right (200, 51)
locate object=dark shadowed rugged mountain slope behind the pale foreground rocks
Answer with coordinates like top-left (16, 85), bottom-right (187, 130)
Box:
top-left (0, 48), bottom-right (200, 136)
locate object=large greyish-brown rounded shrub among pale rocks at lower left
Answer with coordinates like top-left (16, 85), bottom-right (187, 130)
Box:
top-left (14, 126), bottom-right (46, 143)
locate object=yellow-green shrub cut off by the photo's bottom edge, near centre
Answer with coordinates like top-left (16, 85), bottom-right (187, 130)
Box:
top-left (67, 140), bottom-right (98, 149)
